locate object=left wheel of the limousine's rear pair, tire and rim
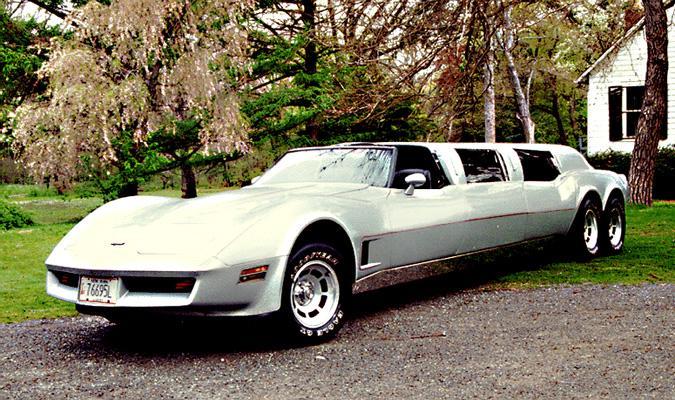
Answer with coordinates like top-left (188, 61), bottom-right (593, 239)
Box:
top-left (568, 198), bottom-right (602, 260)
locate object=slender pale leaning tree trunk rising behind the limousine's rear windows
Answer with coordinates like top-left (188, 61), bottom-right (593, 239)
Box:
top-left (502, 5), bottom-right (535, 143)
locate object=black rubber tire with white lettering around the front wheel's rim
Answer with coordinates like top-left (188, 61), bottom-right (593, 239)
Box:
top-left (281, 243), bottom-right (351, 341)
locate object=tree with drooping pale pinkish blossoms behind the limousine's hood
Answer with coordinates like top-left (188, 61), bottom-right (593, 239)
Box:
top-left (14, 0), bottom-right (252, 197)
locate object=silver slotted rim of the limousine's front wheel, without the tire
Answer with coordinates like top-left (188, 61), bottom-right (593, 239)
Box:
top-left (290, 259), bottom-right (340, 329)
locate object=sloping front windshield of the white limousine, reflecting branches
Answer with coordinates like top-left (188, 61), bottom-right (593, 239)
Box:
top-left (258, 147), bottom-right (393, 187)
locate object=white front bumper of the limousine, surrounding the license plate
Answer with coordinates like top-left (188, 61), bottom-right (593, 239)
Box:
top-left (47, 256), bottom-right (287, 316)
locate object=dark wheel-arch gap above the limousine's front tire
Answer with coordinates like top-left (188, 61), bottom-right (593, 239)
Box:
top-left (291, 220), bottom-right (356, 283)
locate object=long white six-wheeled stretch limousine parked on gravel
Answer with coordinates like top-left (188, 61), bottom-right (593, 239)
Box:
top-left (46, 143), bottom-right (627, 340)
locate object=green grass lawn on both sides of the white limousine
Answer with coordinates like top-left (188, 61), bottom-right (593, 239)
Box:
top-left (0, 185), bottom-right (675, 322)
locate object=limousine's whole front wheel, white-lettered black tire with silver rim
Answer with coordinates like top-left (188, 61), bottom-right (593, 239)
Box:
top-left (282, 244), bottom-right (351, 342)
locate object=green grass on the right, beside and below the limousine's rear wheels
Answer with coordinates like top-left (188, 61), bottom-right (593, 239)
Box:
top-left (436, 203), bottom-right (675, 289)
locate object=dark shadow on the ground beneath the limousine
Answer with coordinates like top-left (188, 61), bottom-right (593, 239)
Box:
top-left (77, 241), bottom-right (570, 357)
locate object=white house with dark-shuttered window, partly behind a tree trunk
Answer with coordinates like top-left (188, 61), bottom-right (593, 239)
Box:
top-left (577, 1), bottom-right (675, 154)
